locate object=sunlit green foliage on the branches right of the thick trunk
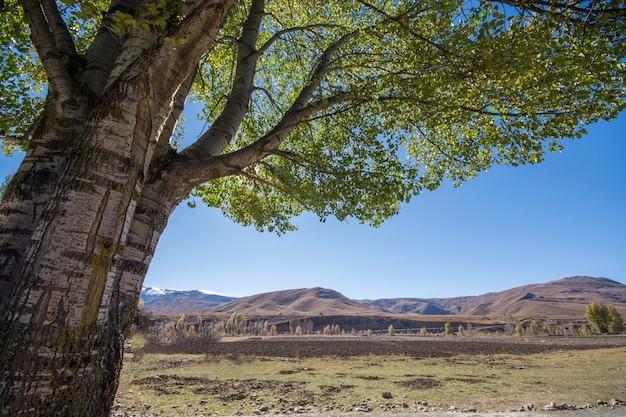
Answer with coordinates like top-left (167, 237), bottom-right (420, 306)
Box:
top-left (194, 1), bottom-right (626, 233)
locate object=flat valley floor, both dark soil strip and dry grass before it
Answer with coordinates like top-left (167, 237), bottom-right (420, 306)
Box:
top-left (112, 335), bottom-right (626, 417)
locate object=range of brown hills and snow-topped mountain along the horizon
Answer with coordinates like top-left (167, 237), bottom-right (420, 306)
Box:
top-left (141, 276), bottom-right (626, 318)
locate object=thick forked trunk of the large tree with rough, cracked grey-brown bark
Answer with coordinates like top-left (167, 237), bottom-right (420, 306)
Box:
top-left (0, 0), bottom-right (232, 417)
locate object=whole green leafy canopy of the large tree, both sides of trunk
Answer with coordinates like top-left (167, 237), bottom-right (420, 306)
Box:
top-left (0, 0), bottom-right (626, 233)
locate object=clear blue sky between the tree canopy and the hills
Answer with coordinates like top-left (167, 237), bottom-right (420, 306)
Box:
top-left (0, 114), bottom-right (626, 299)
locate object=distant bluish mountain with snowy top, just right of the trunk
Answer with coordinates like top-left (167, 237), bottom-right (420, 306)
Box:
top-left (139, 286), bottom-right (236, 314)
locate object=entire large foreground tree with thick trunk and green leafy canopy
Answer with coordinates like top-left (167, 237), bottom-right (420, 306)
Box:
top-left (0, 0), bottom-right (626, 416)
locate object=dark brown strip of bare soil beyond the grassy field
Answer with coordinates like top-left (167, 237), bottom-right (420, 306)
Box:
top-left (139, 335), bottom-right (626, 358)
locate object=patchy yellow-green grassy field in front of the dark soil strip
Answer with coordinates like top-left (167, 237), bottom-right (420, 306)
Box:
top-left (116, 336), bottom-right (626, 416)
